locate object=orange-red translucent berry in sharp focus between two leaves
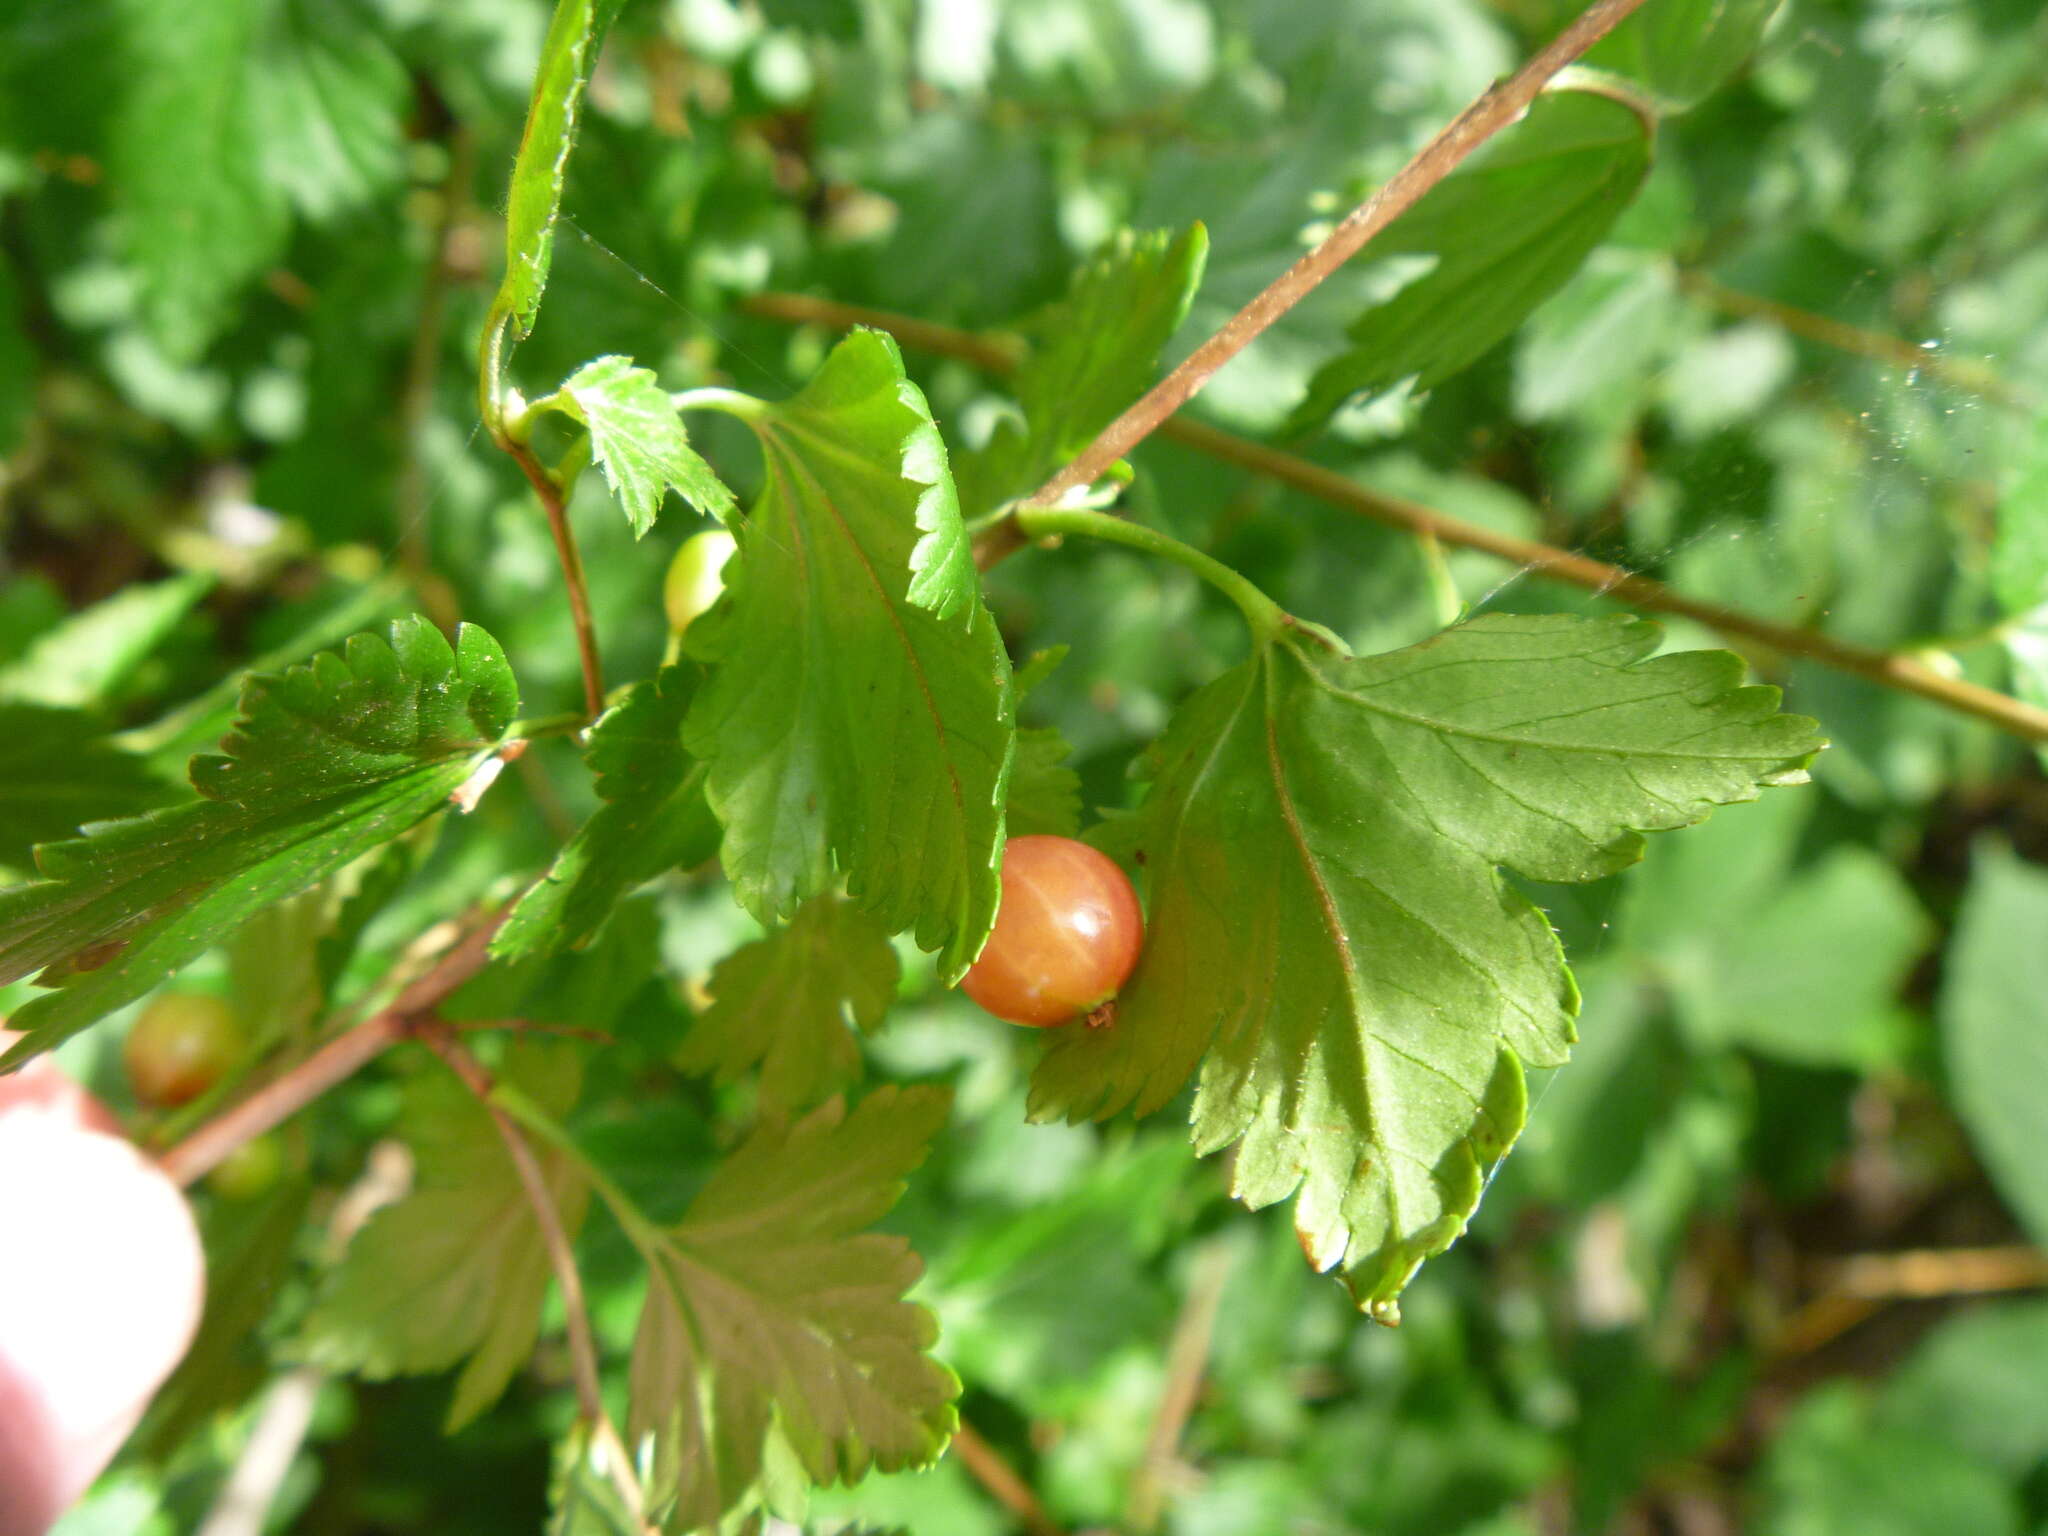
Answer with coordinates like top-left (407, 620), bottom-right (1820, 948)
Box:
top-left (961, 836), bottom-right (1145, 1028)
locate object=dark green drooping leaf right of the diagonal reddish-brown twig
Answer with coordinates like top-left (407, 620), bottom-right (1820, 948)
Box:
top-left (1290, 90), bottom-right (1651, 432)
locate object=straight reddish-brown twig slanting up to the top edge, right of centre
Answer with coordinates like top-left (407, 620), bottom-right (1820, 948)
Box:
top-left (1030, 0), bottom-right (1642, 518)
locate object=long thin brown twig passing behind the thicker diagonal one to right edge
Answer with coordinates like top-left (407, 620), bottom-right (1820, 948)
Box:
top-left (745, 293), bottom-right (2048, 741)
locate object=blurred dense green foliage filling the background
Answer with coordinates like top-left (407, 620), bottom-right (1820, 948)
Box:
top-left (0, 0), bottom-right (2048, 1536)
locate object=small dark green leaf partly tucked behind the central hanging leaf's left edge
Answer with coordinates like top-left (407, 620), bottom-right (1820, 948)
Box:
top-left (492, 664), bottom-right (719, 961)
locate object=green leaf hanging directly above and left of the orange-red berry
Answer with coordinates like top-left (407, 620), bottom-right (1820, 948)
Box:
top-left (684, 330), bottom-right (1014, 981)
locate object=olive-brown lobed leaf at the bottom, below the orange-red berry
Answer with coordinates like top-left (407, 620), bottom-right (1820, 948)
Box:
top-left (629, 1087), bottom-right (961, 1530)
